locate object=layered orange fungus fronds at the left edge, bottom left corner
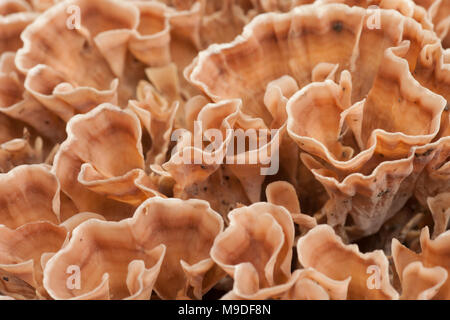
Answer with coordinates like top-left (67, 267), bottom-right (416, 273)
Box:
top-left (0, 164), bottom-right (106, 298)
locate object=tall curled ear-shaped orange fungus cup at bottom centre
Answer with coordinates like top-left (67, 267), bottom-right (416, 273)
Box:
top-left (211, 202), bottom-right (294, 299)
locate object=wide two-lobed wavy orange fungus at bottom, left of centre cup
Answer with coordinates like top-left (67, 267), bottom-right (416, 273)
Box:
top-left (44, 197), bottom-right (223, 299)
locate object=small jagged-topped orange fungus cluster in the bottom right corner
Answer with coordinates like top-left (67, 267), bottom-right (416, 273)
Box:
top-left (392, 227), bottom-right (450, 300)
